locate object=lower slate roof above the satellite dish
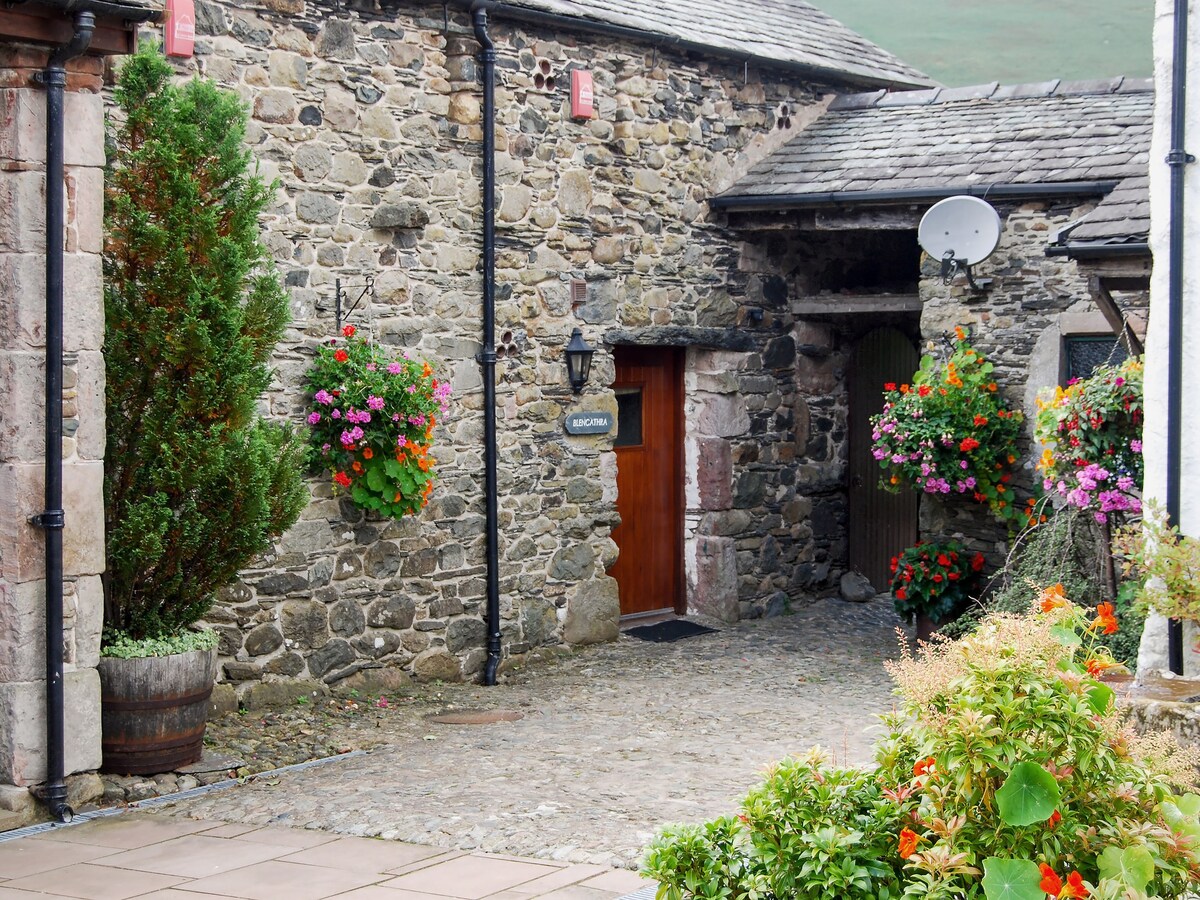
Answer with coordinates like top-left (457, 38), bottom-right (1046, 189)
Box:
top-left (713, 78), bottom-right (1154, 206)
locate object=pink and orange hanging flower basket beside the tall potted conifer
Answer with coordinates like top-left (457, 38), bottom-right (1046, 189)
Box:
top-left (307, 325), bottom-right (450, 517)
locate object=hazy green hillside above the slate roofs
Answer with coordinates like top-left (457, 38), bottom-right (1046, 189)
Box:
top-left (810, 0), bottom-right (1154, 85)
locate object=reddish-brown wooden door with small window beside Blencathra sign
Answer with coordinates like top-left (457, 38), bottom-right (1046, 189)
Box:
top-left (608, 347), bottom-right (685, 616)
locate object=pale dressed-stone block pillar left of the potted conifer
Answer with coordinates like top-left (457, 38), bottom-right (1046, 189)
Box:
top-left (0, 44), bottom-right (104, 787)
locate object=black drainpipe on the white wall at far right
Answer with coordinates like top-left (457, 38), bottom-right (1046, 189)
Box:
top-left (1166, 0), bottom-right (1195, 674)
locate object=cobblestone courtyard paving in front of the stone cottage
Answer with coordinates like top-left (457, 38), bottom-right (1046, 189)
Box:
top-left (162, 599), bottom-right (899, 866)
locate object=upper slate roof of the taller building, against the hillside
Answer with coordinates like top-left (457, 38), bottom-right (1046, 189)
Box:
top-left (493, 0), bottom-right (935, 88)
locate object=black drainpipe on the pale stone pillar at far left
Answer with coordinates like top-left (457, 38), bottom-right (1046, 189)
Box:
top-left (32, 12), bottom-right (96, 822)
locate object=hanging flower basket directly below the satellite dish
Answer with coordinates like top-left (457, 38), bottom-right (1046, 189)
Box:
top-left (871, 329), bottom-right (1025, 523)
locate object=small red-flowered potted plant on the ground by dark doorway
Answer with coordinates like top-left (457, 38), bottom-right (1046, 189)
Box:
top-left (892, 541), bottom-right (983, 622)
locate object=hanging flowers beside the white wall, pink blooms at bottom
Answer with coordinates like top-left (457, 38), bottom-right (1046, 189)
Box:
top-left (1037, 359), bottom-right (1144, 523)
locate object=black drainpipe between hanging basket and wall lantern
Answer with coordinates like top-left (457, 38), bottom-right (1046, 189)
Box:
top-left (470, 1), bottom-right (500, 685)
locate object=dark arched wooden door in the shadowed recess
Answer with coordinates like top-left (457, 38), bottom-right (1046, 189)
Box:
top-left (848, 328), bottom-right (920, 590)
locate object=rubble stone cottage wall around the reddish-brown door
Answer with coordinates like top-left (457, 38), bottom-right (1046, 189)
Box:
top-left (171, 0), bottom-right (844, 694)
